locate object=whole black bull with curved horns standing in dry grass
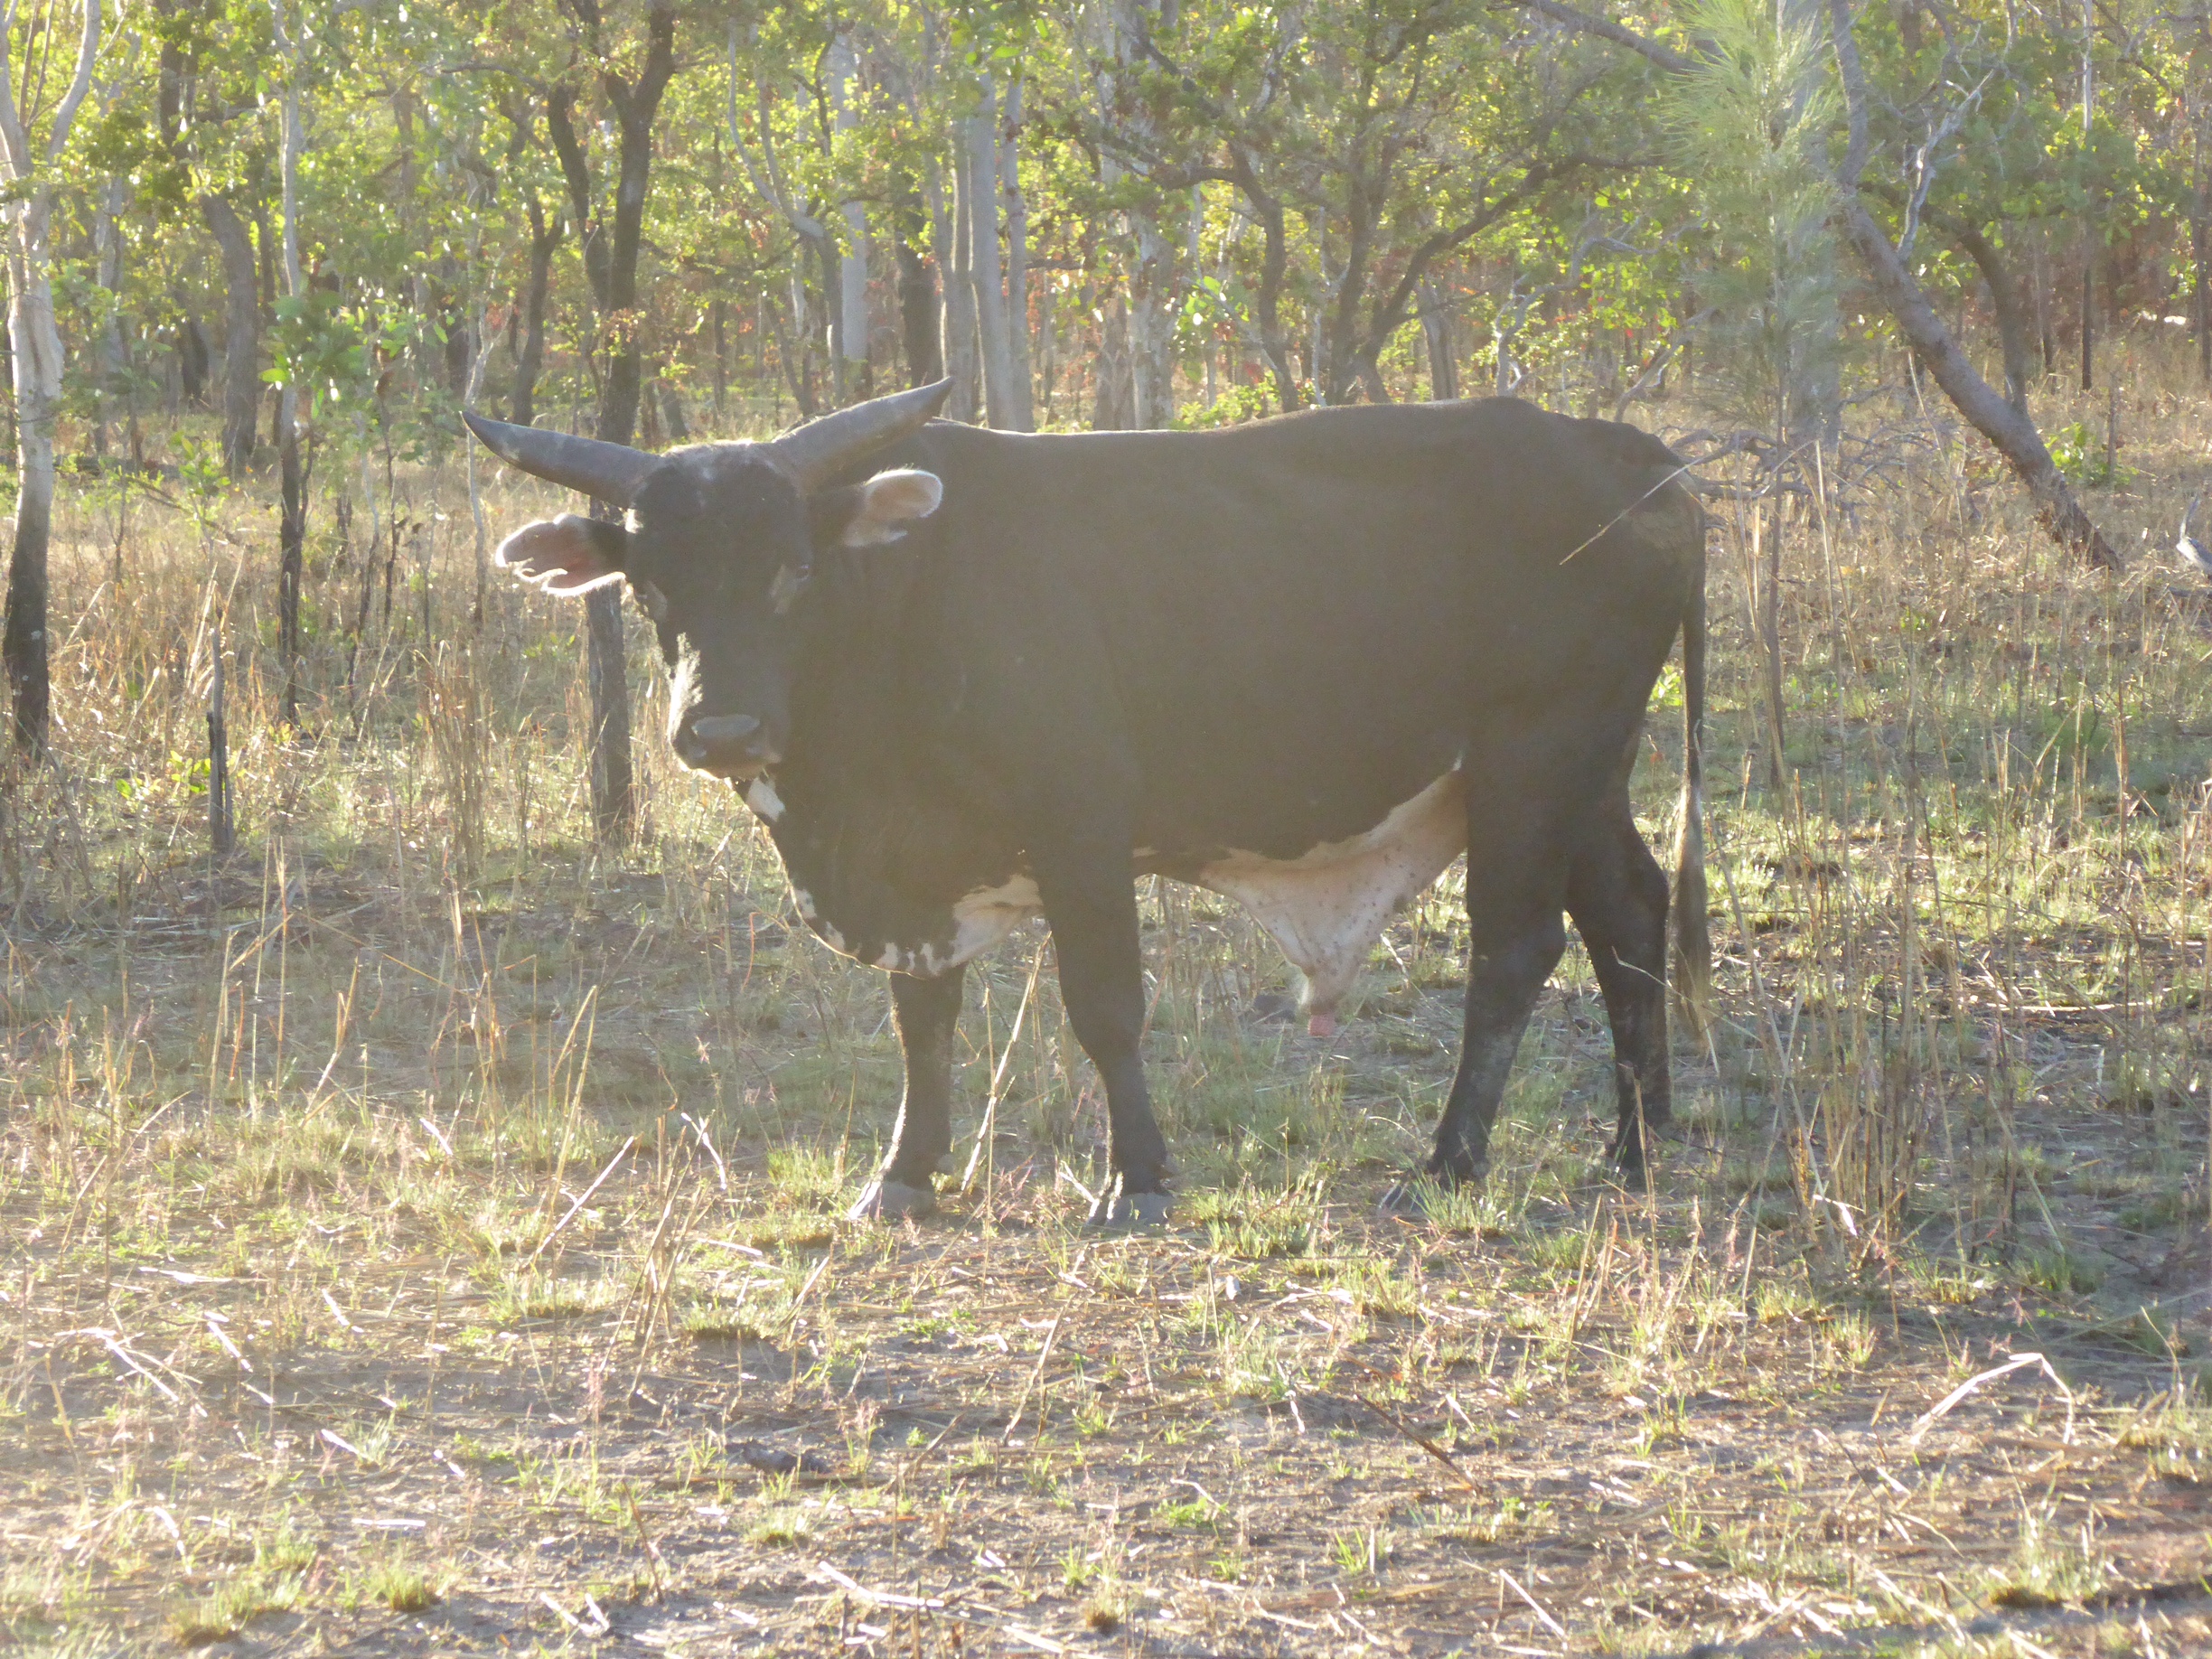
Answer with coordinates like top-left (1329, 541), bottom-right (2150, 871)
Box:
top-left (469, 385), bottom-right (1708, 1223)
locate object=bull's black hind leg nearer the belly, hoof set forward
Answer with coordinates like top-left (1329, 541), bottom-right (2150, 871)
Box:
top-left (1382, 765), bottom-right (1569, 1213)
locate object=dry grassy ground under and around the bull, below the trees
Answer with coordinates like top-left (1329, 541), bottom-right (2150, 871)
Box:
top-left (0, 344), bottom-right (2212, 1654)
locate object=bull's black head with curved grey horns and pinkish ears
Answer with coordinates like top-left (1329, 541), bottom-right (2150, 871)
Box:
top-left (464, 380), bottom-right (951, 779)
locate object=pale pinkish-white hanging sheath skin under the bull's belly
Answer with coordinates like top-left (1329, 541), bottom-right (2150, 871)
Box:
top-left (1196, 770), bottom-right (1467, 1036)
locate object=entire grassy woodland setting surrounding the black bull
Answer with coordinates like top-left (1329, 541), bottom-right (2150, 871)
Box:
top-left (0, 0), bottom-right (2212, 1659)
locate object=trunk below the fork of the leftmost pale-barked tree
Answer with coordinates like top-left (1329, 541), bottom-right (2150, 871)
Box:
top-left (0, 186), bottom-right (62, 755)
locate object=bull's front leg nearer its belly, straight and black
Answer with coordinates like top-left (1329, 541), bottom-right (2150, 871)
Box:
top-left (1031, 836), bottom-right (1175, 1230)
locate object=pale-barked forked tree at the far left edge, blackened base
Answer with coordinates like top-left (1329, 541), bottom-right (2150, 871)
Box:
top-left (0, 0), bottom-right (102, 752)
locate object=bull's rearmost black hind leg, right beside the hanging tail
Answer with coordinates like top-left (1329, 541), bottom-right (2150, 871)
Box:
top-left (1566, 790), bottom-right (1674, 1179)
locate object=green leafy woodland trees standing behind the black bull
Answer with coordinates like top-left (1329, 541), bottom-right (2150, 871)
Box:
top-left (0, 0), bottom-right (2212, 792)
